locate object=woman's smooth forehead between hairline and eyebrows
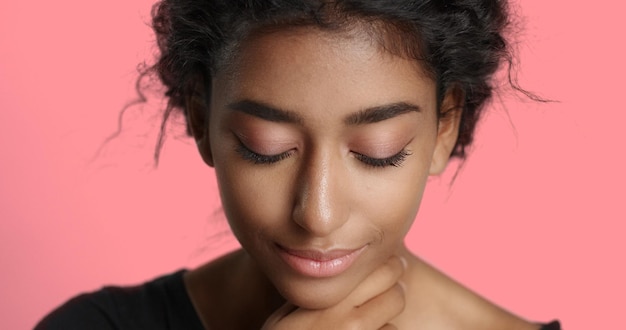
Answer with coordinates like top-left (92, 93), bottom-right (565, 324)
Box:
top-left (214, 28), bottom-right (436, 116)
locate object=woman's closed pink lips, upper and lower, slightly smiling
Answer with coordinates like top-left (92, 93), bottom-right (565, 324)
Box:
top-left (277, 245), bottom-right (367, 278)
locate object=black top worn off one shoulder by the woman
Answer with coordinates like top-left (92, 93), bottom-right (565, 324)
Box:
top-left (35, 270), bottom-right (561, 330)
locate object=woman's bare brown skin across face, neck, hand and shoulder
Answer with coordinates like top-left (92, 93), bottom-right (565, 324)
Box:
top-left (180, 28), bottom-right (538, 330)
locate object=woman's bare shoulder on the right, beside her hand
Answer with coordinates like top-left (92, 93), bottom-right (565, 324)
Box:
top-left (394, 256), bottom-right (540, 330)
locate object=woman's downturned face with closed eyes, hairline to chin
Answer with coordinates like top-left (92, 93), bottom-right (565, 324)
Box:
top-left (191, 28), bottom-right (456, 308)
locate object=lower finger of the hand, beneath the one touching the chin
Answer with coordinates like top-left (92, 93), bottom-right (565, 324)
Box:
top-left (356, 284), bottom-right (405, 329)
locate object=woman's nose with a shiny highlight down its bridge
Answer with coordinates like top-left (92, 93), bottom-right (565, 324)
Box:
top-left (292, 150), bottom-right (350, 237)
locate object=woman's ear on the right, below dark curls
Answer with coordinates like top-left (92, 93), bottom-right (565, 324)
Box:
top-left (430, 87), bottom-right (465, 175)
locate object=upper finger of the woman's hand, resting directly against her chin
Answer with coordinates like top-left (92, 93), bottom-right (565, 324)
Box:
top-left (346, 256), bottom-right (406, 306)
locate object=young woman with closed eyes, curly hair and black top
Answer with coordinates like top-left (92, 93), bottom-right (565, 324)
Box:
top-left (37, 0), bottom-right (559, 330)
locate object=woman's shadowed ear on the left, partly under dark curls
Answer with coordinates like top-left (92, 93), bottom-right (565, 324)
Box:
top-left (185, 75), bottom-right (213, 167)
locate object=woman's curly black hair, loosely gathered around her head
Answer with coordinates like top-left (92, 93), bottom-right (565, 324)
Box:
top-left (149, 0), bottom-right (517, 161)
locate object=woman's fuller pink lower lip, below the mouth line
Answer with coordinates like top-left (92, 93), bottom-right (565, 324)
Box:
top-left (278, 245), bottom-right (367, 278)
